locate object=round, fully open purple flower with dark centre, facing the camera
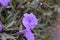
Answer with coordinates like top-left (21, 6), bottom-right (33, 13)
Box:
top-left (22, 13), bottom-right (38, 29)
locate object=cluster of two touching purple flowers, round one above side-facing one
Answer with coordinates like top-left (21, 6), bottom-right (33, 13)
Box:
top-left (18, 13), bottom-right (38, 40)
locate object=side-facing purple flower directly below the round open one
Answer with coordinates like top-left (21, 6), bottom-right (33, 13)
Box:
top-left (18, 29), bottom-right (34, 40)
